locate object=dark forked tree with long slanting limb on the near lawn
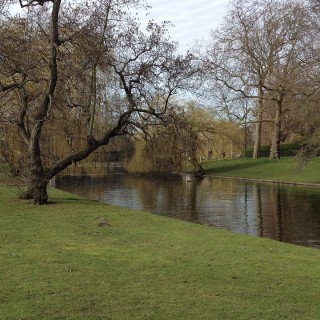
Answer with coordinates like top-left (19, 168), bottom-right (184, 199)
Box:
top-left (0, 0), bottom-right (191, 204)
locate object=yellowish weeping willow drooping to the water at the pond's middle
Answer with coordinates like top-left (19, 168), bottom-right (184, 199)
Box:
top-left (127, 102), bottom-right (216, 175)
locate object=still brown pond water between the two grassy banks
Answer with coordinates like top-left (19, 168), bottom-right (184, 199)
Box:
top-left (57, 174), bottom-right (320, 248)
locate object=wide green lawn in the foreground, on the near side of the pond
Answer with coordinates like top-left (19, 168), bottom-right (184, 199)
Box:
top-left (0, 187), bottom-right (320, 320)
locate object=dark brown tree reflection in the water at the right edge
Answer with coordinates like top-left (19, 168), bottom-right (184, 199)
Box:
top-left (255, 184), bottom-right (320, 247)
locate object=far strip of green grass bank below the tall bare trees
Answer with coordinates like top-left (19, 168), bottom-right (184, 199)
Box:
top-left (203, 157), bottom-right (320, 183)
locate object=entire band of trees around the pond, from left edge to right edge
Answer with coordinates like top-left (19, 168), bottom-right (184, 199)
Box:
top-left (0, 0), bottom-right (320, 204)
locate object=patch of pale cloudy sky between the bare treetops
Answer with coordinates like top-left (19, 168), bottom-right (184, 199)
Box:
top-left (143, 0), bottom-right (229, 52)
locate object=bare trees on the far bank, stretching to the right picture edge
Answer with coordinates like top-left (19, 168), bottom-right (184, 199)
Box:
top-left (200, 0), bottom-right (320, 159)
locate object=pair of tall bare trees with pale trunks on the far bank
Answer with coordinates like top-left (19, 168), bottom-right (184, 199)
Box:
top-left (206, 0), bottom-right (311, 158)
